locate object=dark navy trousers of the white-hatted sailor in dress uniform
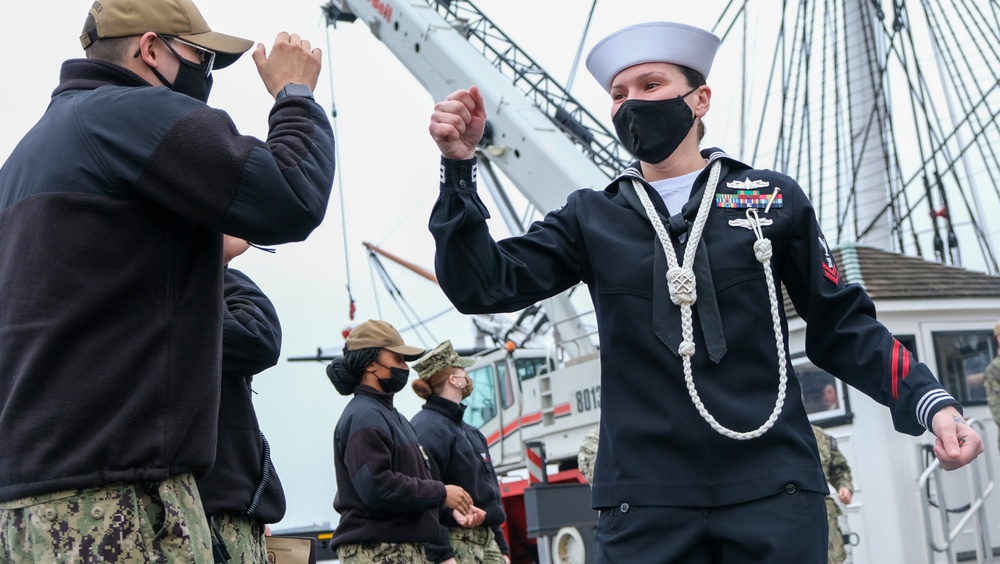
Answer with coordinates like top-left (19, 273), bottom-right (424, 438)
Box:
top-left (597, 485), bottom-right (827, 564)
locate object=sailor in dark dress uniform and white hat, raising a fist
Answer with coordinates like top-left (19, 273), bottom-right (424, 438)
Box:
top-left (429, 18), bottom-right (982, 563)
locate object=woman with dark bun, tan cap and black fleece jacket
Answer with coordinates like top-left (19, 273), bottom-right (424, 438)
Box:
top-left (326, 320), bottom-right (472, 564)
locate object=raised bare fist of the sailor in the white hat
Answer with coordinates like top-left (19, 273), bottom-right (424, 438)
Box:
top-left (428, 86), bottom-right (486, 160)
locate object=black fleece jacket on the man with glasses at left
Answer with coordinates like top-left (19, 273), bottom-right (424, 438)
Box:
top-left (0, 60), bottom-right (334, 501)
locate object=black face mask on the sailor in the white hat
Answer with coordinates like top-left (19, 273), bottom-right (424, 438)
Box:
top-left (611, 86), bottom-right (698, 163)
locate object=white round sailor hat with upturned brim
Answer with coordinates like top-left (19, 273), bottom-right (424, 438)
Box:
top-left (587, 22), bottom-right (722, 92)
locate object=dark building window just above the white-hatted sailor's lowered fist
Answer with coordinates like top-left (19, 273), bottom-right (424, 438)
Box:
top-left (932, 329), bottom-right (996, 405)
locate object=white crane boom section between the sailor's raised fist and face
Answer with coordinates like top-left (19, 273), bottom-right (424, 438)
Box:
top-left (325, 0), bottom-right (626, 213)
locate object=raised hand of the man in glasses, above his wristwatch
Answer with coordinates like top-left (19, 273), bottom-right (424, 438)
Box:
top-left (253, 32), bottom-right (323, 96)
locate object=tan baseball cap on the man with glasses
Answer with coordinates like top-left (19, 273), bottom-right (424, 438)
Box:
top-left (80, 0), bottom-right (254, 69)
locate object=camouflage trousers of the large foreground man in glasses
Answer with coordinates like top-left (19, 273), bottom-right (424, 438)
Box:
top-left (0, 474), bottom-right (212, 564)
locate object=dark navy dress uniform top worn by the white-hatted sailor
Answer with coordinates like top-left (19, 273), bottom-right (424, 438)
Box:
top-left (430, 149), bottom-right (957, 508)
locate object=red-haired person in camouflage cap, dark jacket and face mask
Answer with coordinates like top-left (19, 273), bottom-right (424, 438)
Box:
top-left (410, 341), bottom-right (510, 564)
